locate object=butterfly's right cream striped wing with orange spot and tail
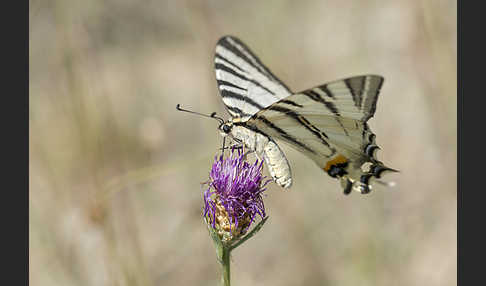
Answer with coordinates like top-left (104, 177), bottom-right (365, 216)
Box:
top-left (246, 75), bottom-right (392, 192)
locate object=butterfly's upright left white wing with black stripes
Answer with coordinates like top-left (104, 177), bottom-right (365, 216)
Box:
top-left (214, 36), bottom-right (292, 120)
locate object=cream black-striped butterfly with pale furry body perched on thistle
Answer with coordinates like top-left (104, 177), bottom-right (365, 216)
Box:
top-left (214, 36), bottom-right (397, 194)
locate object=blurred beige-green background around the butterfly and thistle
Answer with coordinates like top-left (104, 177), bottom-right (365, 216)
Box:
top-left (29, 0), bottom-right (457, 286)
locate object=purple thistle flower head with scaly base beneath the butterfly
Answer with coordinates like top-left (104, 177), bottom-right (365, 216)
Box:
top-left (204, 150), bottom-right (271, 241)
